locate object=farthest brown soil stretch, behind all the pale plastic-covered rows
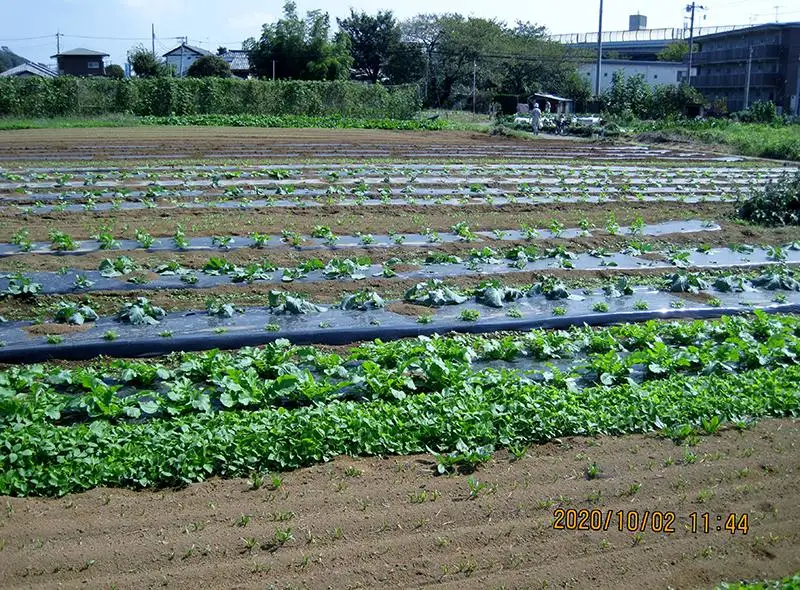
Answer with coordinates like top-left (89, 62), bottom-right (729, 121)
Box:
top-left (0, 127), bottom-right (724, 162)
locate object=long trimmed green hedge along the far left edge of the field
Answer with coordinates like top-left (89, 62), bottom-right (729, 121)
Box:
top-left (0, 77), bottom-right (421, 119)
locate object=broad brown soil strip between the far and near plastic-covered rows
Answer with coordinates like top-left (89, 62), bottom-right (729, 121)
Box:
top-left (0, 202), bottom-right (733, 242)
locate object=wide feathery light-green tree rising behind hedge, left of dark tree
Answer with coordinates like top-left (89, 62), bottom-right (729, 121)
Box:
top-left (243, 1), bottom-right (353, 80)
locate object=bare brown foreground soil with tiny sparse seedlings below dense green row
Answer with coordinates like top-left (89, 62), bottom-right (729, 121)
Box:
top-left (0, 420), bottom-right (800, 590)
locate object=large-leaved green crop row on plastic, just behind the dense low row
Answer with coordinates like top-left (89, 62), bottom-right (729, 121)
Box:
top-left (0, 312), bottom-right (800, 427)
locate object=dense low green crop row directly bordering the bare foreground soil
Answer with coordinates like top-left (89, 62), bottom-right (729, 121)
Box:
top-left (0, 366), bottom-right (800, 496)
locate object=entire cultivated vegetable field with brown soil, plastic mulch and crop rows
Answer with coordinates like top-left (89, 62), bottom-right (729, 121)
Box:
top-left (0, 128), bottom-right (800, 588)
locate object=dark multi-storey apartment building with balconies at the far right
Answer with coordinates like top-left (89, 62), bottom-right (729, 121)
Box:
top-left (692, 22), bottom-right (800, 114)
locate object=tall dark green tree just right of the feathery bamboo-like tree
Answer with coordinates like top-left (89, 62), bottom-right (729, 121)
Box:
top-left (337, 8), bottom-right (400, 83)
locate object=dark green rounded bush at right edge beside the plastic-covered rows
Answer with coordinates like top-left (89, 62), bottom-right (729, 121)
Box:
top-left (739, 171), bottom-right (800, 225)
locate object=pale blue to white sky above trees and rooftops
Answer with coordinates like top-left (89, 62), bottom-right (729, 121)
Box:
top-left (0, 0), bottom-right (800, 64)
